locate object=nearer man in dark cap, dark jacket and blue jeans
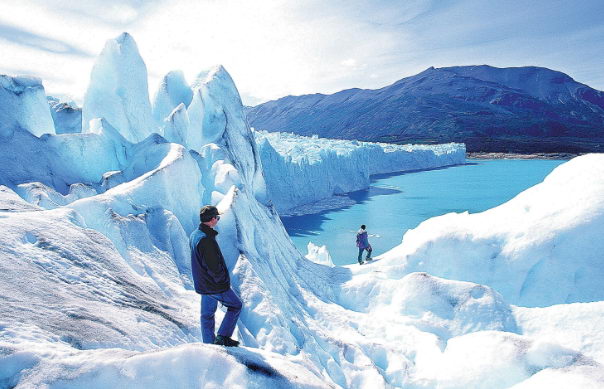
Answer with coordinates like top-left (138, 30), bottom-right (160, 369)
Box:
top-left (189, 205), bottom-right (242, 347)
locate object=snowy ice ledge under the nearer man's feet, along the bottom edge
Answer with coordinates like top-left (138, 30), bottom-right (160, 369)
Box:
top-left (0, 323), bottom-right (330, 389)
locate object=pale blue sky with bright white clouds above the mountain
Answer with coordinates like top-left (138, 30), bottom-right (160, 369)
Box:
top-left (0, 0), bottom-right (604, 105)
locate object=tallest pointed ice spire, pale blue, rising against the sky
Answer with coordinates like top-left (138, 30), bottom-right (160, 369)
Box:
top-left (82, 32), bottom-right (156, 142)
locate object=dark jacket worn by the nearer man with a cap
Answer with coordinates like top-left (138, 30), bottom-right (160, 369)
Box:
top-left (189, 223), bottom-right (231, 294)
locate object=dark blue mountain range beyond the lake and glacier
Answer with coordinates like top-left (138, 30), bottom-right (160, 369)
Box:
top-left (247, 65), bottom-right (604, 153)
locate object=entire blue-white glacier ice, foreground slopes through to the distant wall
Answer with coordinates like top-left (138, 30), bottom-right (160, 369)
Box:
top-left (0, 31), bottom-right (604, 389)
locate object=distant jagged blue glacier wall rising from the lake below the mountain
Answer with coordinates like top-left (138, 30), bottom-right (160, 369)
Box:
top-left (255, 131), bottom-right (466, 214)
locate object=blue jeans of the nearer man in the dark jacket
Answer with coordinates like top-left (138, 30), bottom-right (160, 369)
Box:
top-left (201, 289), bottom-right (242, 343)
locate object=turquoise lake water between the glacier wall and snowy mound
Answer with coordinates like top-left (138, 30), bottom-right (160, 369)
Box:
top-left (282, 159), bottom-right (565, 265)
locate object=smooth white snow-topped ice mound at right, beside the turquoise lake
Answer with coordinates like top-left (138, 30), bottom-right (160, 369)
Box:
top-left (372, 154), bottom-right (604, 307)
